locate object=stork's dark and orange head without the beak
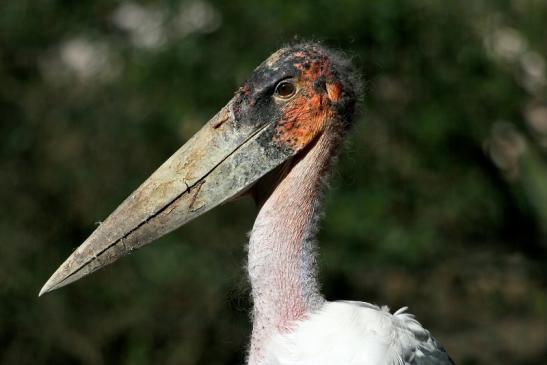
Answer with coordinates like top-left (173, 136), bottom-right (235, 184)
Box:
top-left (233, 44), bottom-right (356, 151)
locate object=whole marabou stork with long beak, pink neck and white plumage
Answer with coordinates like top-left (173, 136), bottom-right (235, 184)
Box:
top-left (40, 43), bottom-right (452, 365)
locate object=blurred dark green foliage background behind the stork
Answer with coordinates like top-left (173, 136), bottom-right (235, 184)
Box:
top-left (0, 0), bottom-right (547, 365)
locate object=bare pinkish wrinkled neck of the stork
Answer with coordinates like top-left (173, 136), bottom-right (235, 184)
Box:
top-left (248, 132), bottom-right (337, 365)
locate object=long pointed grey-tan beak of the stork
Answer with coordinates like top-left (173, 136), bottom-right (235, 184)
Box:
top-left (39, 102), bottom-right (294, 295)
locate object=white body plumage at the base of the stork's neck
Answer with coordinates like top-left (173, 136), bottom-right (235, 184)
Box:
top-left (264, 301), bottom-right (453, 365)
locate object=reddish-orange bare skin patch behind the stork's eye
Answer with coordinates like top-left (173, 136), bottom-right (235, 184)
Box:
top-left (274, 60), bottom-right (341, 151)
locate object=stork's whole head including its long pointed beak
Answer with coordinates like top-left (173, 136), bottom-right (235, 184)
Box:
top-left (40, 43), bottom-right (359, 295)
